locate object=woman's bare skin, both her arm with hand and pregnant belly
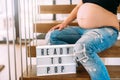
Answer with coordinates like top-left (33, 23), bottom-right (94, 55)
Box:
top-left (50, 0), bottom-right (119, 30)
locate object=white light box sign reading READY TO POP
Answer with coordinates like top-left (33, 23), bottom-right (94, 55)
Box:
top-left (36, 45), bottom-right (76, 76)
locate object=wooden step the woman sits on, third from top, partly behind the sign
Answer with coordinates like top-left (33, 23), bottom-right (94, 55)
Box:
top-left (27, 39), bottom-right (120, 58)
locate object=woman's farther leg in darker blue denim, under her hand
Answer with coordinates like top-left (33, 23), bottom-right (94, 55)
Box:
top-left (47, 27), bottom-right (82, 45)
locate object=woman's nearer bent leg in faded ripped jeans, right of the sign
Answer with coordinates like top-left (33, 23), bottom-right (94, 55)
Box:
top-left (74, 28), bottom-right (118, 80)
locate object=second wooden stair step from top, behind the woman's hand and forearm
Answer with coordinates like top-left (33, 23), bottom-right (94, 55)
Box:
top-left (34, 20), bottom-right (78, 33)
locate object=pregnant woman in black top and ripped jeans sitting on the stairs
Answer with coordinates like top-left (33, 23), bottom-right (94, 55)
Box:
top-left (47, 0), bottom-right (120, 80)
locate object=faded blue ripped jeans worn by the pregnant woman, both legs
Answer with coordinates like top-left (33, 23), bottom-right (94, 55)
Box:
top-left (46, 26), bottom-right (118, 80)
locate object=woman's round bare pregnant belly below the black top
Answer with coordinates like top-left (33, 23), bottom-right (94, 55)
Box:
top-left (77, 3), bottom-right (119, 29)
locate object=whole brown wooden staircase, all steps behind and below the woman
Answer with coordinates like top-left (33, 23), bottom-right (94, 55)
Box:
top-left (19, 1), bottom-right (120, 80)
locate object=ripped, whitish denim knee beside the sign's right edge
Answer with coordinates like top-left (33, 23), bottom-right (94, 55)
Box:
top-left (74, 42), bottom-right (96, 63)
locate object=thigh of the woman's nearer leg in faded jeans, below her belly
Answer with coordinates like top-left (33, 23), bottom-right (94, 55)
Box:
top-left (76, 27), bottom-right (118, 53)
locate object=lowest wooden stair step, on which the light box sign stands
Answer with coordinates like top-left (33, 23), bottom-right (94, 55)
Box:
top-left (19, 65), bottom-right (120, 80)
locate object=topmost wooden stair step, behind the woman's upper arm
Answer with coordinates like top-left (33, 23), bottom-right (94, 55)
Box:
top-left (38, 5), bottom-right (120, 14)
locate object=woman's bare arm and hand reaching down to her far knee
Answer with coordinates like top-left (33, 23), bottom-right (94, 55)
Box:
top-left (50, 0), bottom-right (83, 31)
